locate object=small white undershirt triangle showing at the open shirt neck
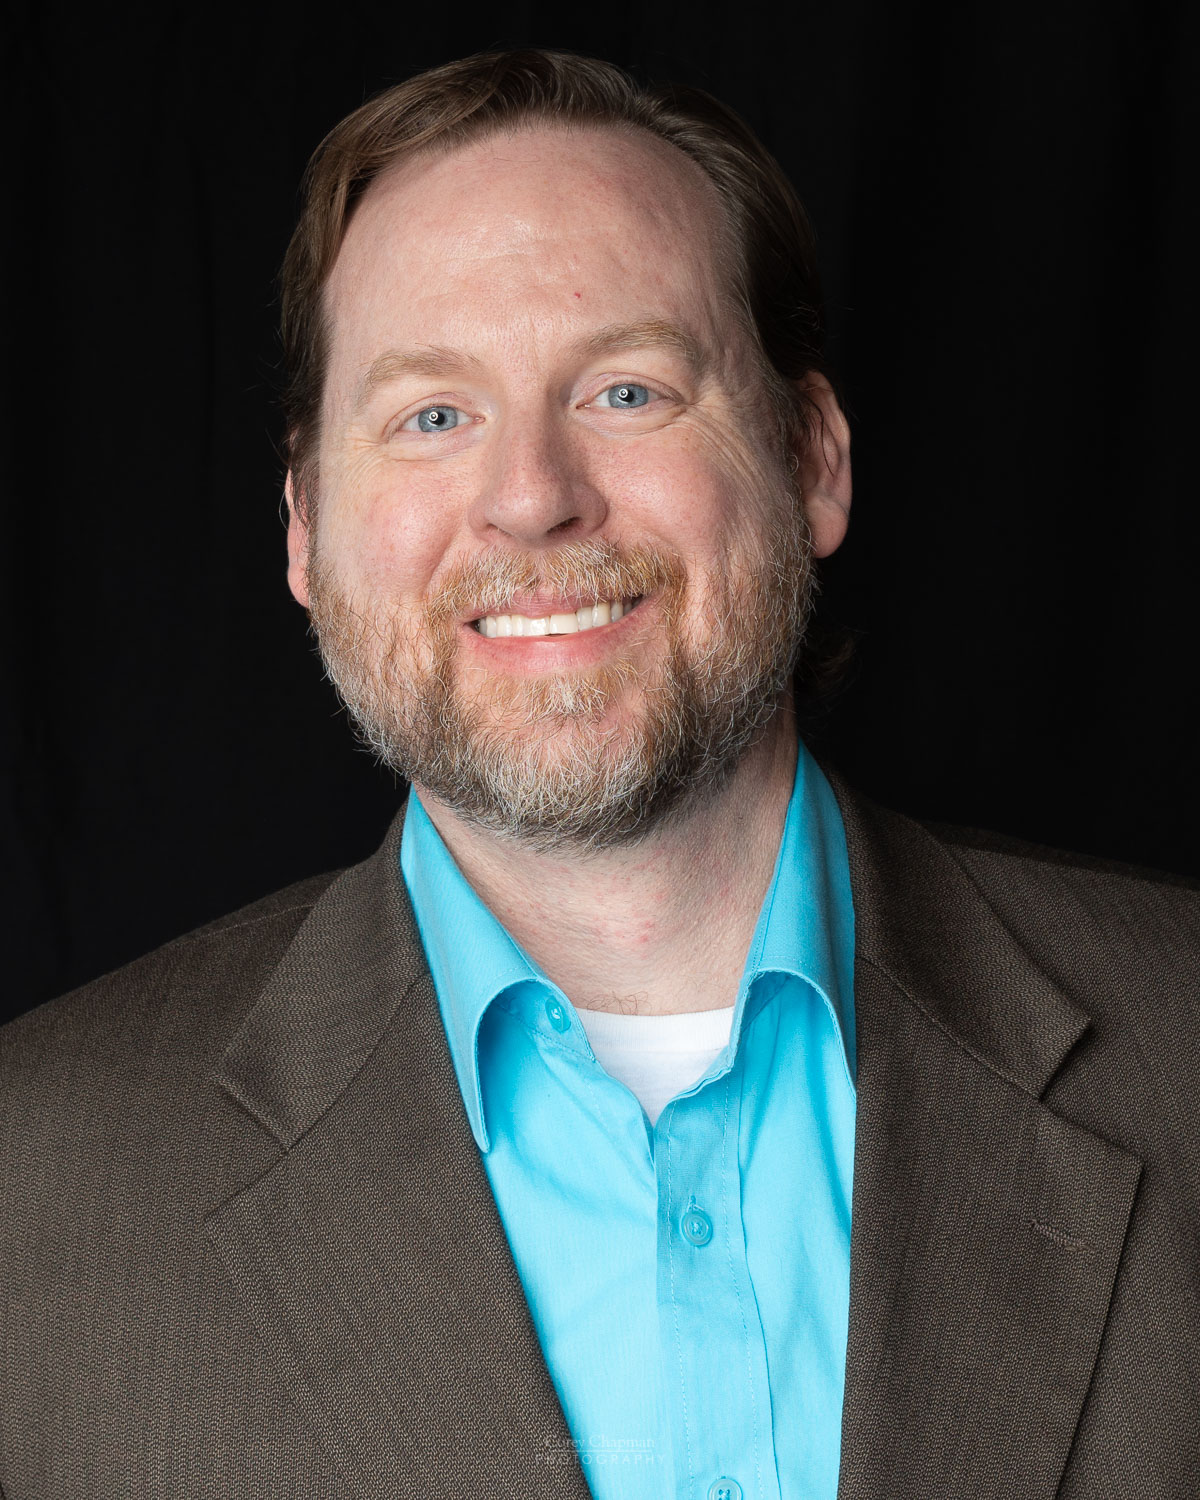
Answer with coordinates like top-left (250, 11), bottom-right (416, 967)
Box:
top-left (576, 1005), bottom-right (734, 1125)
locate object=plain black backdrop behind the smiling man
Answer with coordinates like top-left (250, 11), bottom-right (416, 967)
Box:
top-left (0, 0), bottom-right (1200, 1013)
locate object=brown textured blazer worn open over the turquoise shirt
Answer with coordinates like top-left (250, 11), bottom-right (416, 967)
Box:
top-left (0, 782), bottom-right (1200, 1500)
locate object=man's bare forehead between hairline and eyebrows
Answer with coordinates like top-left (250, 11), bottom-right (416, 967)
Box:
top-left (327, 128), bottom-right (731, 377)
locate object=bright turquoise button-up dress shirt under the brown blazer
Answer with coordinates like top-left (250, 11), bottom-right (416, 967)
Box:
top-left (401, 746), bottom-right (855, 1500)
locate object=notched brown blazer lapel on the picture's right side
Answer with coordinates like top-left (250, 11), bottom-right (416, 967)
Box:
top-left (831, 777), bottom-right (1140, 1500)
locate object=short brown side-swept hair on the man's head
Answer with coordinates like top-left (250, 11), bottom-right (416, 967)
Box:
top-left (282, 50), bottom-right (828, 513)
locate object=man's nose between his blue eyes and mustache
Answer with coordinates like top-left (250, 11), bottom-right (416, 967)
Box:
top-left (471, 419), bottom-right (608, 549)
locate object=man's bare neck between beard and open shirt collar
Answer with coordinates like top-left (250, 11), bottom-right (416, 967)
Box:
top-left (417, 704), bottom-right (798, 1016)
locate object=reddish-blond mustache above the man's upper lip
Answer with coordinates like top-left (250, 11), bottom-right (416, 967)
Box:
top-left (429, 537), bottom-right (687, 626)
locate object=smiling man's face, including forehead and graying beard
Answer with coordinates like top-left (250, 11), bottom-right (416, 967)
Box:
top-left (290, 129), bottom-right (836, 849)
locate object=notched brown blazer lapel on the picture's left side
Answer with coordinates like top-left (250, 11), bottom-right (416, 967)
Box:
top-left (207, 815), bottom-right (588, 1500)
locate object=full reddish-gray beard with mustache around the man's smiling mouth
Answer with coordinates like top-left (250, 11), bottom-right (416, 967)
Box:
top-left (309, 485), bottom-right (815, 854)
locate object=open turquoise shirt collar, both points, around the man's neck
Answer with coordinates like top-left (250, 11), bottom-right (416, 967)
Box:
top-left (401, 744), bottom-right (855, 1152)
